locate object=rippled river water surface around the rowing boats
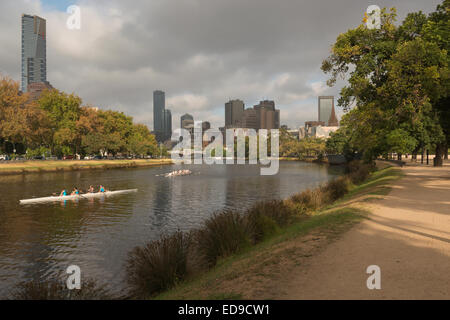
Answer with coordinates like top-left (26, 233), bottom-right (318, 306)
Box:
top-left (0, 162), bottom-right (341, 297)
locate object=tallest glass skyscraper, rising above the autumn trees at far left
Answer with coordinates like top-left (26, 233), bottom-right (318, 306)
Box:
top-left (21, 14), bottom-right (47, 92)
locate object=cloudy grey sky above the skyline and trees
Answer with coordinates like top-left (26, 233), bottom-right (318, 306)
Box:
top-left (0, 0), bottom-right (441, 128)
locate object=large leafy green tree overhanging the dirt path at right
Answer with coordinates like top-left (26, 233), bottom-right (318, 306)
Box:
top-left (322, 0), bottom-right (449, 164)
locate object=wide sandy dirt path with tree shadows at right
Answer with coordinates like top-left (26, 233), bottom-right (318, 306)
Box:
top-left (284, 164), bottom-right (450, 299)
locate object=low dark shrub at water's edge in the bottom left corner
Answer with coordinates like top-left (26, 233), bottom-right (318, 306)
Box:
top-left (12, 279), bottom-right (112, 300)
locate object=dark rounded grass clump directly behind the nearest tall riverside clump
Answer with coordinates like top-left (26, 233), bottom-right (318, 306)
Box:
top-left (196, 211), bottom-right (250, 267)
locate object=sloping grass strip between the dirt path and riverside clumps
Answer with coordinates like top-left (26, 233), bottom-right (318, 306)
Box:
top-left (156, 164), bottom-right (402, 299)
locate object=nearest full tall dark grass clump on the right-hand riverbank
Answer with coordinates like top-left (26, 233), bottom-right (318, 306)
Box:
top-left (126, 231), bottom-right (191, 298)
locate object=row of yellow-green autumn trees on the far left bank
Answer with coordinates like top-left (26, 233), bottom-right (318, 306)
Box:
top-left (0, 77), bottom-right (157, 155)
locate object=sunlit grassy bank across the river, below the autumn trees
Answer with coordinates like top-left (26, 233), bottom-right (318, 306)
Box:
top-left (0, 159), bottom-right (172, 175)
